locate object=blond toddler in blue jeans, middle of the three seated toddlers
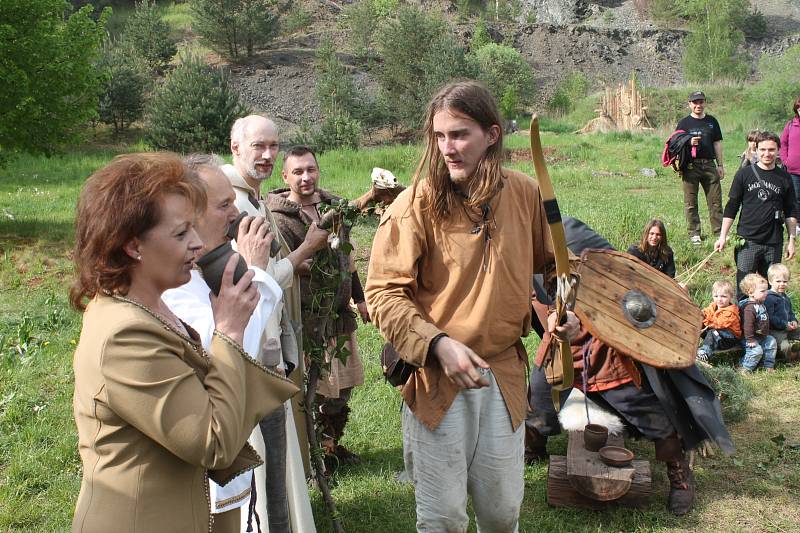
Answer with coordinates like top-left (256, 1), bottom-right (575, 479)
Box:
top-left (739, 274), bottom-right (778, 373)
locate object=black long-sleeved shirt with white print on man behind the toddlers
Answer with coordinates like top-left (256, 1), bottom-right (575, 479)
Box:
top-left (723, 165), bottom-right (797, 244)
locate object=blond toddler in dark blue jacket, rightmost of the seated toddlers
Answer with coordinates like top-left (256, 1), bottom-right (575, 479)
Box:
top-left (764, 263), bottom-right (800, 361)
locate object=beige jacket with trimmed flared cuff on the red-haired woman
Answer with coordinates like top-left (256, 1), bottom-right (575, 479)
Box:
top-left (72, 296), bottom-right (297, 533)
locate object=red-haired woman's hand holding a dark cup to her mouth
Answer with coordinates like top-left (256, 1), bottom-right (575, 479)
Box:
top-left (211, 255), bottom-right (258, 344)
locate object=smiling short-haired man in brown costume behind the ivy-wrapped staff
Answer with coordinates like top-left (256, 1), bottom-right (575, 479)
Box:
top-left (267, 146), bottom-right (369, 464)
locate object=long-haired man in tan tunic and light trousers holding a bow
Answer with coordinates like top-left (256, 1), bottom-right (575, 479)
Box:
top-left (366, 81), bottom-right (578, 532)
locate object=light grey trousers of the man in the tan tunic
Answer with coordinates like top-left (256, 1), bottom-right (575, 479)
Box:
top-left (403, 372), bottom-right (525, 533)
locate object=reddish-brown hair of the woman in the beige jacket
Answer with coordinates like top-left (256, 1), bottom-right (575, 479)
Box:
top-left (69, 152), bottom-right (206, 311)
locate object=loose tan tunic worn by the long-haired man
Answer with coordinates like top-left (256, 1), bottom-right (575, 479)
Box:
top-left (365, 169), bottom-right (554, 429)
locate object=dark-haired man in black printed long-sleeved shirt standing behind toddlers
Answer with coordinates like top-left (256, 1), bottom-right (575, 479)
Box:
top-left (714, 132), bottom-right (797, 300)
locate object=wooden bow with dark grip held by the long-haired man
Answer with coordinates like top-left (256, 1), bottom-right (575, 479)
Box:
top-left (530, 115), bottom-right (577, 410)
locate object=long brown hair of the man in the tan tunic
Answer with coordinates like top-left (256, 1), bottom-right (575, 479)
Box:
top-left (413, 80), bottom-right (503, 222)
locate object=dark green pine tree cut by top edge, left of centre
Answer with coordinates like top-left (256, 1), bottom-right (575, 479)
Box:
top-left (191, 0), bottom-right (278, 59)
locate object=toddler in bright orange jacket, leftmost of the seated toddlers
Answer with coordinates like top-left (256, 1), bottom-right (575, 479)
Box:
top-left (697, 280), bottom-right (742, 361)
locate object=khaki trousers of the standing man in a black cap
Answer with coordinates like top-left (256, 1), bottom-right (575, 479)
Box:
top-left (681, 159), bottom-right (722, 237)
